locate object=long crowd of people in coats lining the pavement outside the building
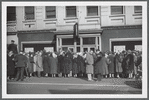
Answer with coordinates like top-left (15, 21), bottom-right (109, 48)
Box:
top-left (7, 46), bottom-right (142, 81)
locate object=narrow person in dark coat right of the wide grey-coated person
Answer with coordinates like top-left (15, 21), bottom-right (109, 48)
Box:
top-left (108, 52), bottom-right (114, 78)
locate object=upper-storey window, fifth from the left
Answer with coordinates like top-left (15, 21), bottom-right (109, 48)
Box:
top-left (87, 6), bottom-right (98, 16)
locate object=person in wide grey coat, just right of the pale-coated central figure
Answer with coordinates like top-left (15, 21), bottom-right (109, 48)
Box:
top-left (95, 52), bottom-right (110, 81)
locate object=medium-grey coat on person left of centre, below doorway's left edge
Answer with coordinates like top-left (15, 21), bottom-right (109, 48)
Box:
top-left (49, 57), bottom-right (58, 74)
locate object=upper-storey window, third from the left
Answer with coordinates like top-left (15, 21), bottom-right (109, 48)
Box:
top-left (46, 6), bottom-right (56, 19)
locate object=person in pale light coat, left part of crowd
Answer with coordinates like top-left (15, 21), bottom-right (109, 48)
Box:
top-left (35, 52), bottom-right (43, 78)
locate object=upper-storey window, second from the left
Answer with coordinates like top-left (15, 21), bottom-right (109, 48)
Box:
top-left (25, 6), bottom-right (35, 20)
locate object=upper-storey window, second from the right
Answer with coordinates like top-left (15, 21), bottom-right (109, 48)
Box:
top-left (111, 6), bottom-right (124, 15)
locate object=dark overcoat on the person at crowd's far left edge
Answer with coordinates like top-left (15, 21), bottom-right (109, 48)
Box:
top-left (7, 55), bottom-right (15, 76)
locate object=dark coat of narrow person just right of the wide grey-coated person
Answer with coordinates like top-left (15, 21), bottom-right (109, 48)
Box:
top-left (108, 54), bottom-right (115, 74)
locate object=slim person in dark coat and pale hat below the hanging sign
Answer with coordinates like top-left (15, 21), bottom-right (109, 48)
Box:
top-left (72, 54), bottom-right (78, 77)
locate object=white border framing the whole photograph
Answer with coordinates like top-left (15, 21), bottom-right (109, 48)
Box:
top-left (2, 1), bottom-right (148, 98)
